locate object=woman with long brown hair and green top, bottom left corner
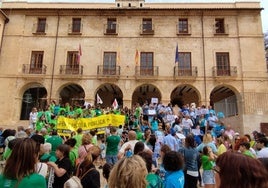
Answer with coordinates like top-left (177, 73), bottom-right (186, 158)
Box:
top-left (0, 138), bottom-right (46, 188)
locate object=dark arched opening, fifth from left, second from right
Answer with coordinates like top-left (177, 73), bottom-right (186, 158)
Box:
top-left (170, 85), bottom-right (200, 108)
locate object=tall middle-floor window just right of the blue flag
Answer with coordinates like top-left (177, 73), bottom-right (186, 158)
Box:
top-left (178, 52), bottom-right (192, 76)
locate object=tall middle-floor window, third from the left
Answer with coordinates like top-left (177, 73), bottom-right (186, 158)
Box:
top-left (103, 52), bottom-right (117, 75)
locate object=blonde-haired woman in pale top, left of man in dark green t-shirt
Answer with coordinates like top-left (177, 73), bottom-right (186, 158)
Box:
top-left (76, 133), bottom-right (93, 166)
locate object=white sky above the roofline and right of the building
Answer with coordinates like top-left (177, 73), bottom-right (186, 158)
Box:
top-left (3, 0), bottom-right (268, 32)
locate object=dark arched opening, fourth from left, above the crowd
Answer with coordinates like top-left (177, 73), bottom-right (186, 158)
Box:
top-left (132, 84), bottom-right (161, 105)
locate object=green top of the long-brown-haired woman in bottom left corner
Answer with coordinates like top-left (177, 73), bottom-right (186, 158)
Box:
top-left (0, 173), bottom-right (46, 188)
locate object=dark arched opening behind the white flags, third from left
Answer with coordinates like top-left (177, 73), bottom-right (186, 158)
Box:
top-left (95, 83), bottom-right (123, 107)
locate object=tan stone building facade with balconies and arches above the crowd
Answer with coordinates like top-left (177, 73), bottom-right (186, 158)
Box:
top-left (0, 0), bottom-right (268, 133)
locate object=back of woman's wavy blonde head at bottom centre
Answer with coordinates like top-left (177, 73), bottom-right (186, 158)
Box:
top-left (108, 155), bottom-right (148, 188)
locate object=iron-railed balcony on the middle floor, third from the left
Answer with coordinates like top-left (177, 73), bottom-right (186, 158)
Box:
top-left (97, 65), bottom-right (121, 80)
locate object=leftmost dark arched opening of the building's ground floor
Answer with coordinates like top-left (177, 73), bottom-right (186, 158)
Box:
top-left (20, 84), bottom-right (47, 120)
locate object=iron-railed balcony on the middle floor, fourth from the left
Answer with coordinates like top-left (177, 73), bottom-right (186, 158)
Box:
top-left (135, 66), bottom-right (159, 80)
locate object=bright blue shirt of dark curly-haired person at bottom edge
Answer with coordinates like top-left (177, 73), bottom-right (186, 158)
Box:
top-left (164, 170), bottom-right (184, 188)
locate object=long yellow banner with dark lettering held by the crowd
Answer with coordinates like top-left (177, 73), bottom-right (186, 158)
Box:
top-left (57, 114), bottom-right (125, 136)
